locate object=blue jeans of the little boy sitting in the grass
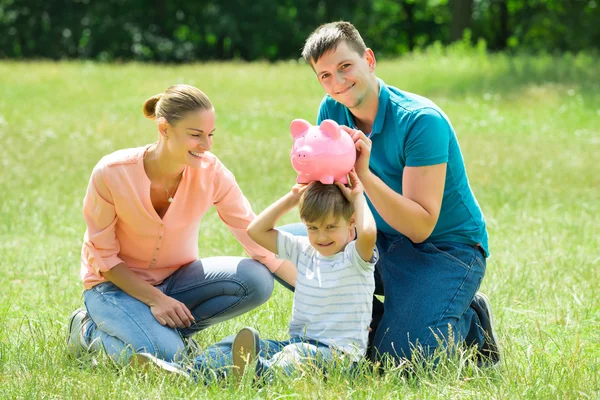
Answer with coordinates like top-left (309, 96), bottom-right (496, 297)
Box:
top-left (192, 335), bottom-right (346, 384)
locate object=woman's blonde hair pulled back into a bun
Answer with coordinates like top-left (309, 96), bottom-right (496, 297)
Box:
top-left (142, 84), bottom-right (213, 124)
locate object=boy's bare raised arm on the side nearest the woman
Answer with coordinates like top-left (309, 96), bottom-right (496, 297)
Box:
top-left (248, 185), bottom-right (307, 254)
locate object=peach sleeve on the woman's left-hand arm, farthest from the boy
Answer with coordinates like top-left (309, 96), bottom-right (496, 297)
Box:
top-left (82, 165), bottom-right (123, 276)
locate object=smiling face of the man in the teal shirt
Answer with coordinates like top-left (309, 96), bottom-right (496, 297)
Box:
top-left (313, 41), bottom-right (375, 109)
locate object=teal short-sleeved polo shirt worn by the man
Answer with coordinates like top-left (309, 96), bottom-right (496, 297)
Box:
top-left (317, 79), bottom-right (489, 255)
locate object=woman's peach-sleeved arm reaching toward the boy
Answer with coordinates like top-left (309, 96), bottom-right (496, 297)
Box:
top-left (214, 164), bottom-right (283, 272)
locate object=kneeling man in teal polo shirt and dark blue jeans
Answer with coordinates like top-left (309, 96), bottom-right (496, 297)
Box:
top-left (302, 21), bottom-right (500, 365)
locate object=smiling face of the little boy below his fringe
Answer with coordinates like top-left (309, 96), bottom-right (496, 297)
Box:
top-left (304, 214), bottom-right (354, 256)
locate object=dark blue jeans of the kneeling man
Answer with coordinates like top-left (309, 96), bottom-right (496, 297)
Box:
top-left (275, 223), bottom-right (486, 360)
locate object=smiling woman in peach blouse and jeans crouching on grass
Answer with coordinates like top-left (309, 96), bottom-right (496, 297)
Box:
top-left (67, 85), bottom-right (281, 363)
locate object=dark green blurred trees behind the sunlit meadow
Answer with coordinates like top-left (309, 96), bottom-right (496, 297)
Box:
top-left (0, 0), bottom-right (600, 63)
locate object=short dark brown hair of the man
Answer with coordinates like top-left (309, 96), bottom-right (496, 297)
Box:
top-left (302, 21), bottom-right (367, 65)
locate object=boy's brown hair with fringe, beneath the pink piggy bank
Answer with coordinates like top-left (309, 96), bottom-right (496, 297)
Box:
top-left (298, 181), bottom-right (354, 222)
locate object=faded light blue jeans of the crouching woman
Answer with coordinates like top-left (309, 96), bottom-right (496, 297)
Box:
top-left (84, 257), bottom-right (273, 363)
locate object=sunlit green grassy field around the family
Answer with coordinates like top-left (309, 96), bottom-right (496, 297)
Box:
top-left (0, 49), bottom-right (600, 399)
